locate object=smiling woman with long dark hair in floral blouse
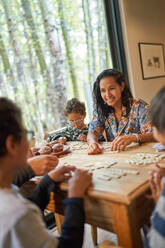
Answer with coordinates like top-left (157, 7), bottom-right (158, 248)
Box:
top-left (87, 69), bottom-right (153, 154)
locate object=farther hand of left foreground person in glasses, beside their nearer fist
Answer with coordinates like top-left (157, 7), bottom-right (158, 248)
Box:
top-left (48, 166), bottom-right (75, 183)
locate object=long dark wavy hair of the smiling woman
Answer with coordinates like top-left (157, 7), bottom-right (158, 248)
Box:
top-left (93, 69), bottom-right (133, 126)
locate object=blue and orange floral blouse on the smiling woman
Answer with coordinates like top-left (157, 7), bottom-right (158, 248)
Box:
top-left (89, 99), bottom-right (152, 141)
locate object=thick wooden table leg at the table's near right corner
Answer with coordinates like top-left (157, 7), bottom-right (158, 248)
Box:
top-left (112, 203), bottom-right (143, 248)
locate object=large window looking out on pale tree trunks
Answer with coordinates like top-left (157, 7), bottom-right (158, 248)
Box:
top-left (0, 0), bottom-right (125, 135)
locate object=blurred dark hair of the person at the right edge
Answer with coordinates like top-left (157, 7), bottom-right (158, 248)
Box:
top-left (149, 87), bottom-right (165, 133)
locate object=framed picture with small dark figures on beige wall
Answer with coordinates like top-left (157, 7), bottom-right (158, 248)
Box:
top-left (139, 42), bottom-right (165, 80)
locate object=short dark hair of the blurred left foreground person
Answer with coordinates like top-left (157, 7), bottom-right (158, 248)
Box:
top-left (0, 97), bottom-right (22, 156)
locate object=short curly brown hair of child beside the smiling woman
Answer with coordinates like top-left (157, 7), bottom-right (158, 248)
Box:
top-left (65, 98), bottom-right (86, 116)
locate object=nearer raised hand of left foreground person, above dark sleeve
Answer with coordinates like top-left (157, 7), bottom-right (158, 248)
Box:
top-left (68, 169), bottom-right (92, 198)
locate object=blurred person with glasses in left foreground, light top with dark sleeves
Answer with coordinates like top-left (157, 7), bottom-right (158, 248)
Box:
top-left (0, 98), bottom-right (92, 248)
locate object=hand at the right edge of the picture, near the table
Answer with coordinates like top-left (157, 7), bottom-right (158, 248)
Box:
top-left (149, 164), bottom-right (165, 203)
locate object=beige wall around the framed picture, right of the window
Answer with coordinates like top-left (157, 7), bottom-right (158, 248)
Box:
top-left (119, 0), bottom-right (165, 102)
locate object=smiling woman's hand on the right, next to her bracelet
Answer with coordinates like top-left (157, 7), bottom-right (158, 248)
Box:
top-left (111, 134), bottom-right (136, 151)
